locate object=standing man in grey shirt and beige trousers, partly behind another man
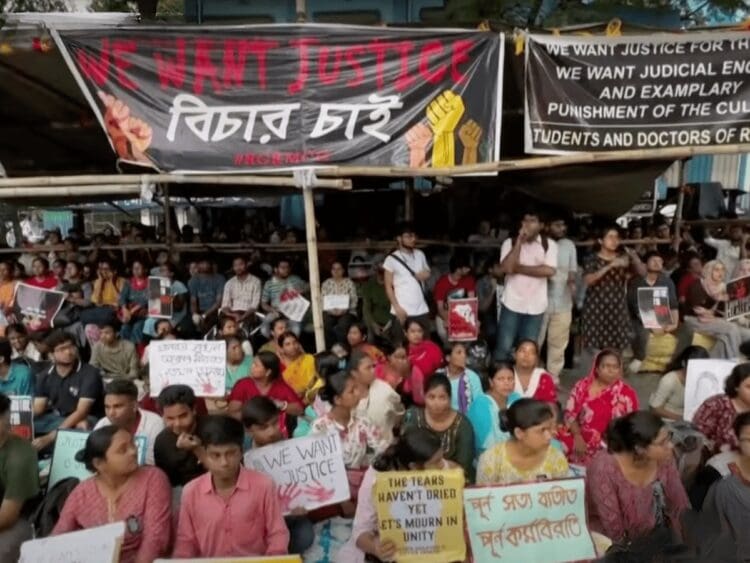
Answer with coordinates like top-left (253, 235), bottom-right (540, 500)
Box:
top-left (539, 217), bottom-right (578, 383)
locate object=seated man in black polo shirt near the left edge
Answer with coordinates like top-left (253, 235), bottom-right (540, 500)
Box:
top-left (32, 330), bottom-right (104, 450)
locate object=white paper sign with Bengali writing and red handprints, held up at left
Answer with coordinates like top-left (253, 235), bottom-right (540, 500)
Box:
top-left (148, 340), bottom-right (227, 397)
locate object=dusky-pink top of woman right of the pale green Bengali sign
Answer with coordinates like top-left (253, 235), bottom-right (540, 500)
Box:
top-left (586, 451), bottom-right (690, 542)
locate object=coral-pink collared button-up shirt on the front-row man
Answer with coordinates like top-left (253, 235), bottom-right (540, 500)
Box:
top-left (172, 468), bottom-right (289, 558)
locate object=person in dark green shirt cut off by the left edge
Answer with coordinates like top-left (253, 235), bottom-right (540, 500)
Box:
top-left (0, 393), bottom-right (39, 562)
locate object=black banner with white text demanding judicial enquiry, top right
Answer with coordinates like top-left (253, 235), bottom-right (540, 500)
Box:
top-left (525, 32), bottom-right (750, 154)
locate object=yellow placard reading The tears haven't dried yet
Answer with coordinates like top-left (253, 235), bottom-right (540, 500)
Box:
top-left (373, 469), bottom-right (466, 563)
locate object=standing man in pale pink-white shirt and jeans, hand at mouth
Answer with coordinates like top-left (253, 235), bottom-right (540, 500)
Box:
top-left (495, 211), bottom-right (557, 361)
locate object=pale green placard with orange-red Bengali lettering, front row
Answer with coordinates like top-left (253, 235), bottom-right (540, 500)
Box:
top-left (464, 479), bottom-right (596, 563)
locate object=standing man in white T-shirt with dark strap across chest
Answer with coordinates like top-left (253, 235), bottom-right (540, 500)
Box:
top-left (383, 223), bottom-right (430, 343)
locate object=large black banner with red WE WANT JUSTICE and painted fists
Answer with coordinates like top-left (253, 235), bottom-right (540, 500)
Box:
top-left (55, 25), bottom-right (503, 172)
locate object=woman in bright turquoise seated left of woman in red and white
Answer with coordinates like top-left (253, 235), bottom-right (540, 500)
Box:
top-left (466, 362), bottom-right (521, 457)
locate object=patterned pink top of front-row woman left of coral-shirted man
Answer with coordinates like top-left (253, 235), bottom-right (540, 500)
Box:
top-left (52, 465), bottom-right (172, 563)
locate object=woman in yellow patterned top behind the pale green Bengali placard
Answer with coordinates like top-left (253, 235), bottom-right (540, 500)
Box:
top-left (477, 398), bottom-right (568, 485)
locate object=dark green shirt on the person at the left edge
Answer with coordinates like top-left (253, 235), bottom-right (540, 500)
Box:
top-left (0, 434), bottom-right (39, 503)
